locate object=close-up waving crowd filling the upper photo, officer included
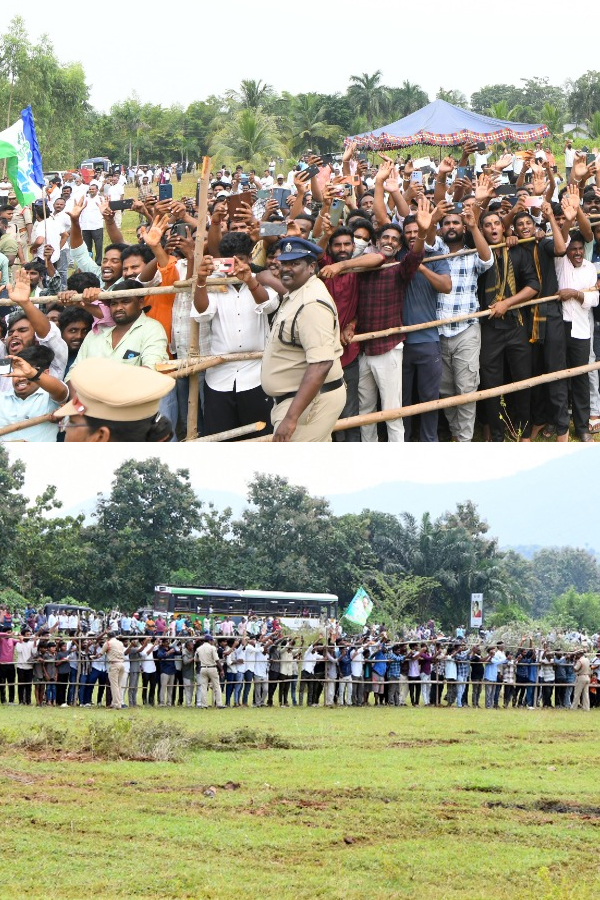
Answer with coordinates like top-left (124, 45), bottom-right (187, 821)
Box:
top-left (0, 142), bottom-right (600, 442)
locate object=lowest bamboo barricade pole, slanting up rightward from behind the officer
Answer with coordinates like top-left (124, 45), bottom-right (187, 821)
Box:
top-left (250, 362), bottom-right (600, 443)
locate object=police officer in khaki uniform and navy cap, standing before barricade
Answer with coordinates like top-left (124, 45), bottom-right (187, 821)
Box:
top-left (262, 238), bottom-right (346, 441)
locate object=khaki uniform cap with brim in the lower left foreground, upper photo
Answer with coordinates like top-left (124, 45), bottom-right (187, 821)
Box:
top-left (54, 359), bottom-right (175, 422)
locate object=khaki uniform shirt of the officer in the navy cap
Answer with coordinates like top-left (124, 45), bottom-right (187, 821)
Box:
top-left (261, 275), bottom-right (342, 397)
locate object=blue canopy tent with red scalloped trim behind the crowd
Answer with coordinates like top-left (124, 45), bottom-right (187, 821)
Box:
top-left (346, 100), bottom-right (549, 150)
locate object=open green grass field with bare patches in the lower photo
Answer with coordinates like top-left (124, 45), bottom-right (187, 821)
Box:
top-left (0, 707), bottom-right (600, 900)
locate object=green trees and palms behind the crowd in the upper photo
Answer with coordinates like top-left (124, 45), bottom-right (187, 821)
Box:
top-left (0, 16), bottom-right (600, 170)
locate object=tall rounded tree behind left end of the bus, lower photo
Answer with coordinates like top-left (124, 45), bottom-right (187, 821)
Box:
top-left (85, 459), bottom-right (201, 609)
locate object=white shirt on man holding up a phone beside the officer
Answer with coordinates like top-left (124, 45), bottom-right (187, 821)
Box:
top-left (191, 284), bottom-right (279, 392)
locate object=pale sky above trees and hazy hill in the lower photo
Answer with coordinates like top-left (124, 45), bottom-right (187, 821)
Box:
top-left (4, 442), bottom-right (594, 511)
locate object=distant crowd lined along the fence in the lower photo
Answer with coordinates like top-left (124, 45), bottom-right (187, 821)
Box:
top-left (0, 610), bottom-right (600, 711)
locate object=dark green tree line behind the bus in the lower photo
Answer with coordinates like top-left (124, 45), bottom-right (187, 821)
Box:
top-left (0, 448), bottom-right (600, 630)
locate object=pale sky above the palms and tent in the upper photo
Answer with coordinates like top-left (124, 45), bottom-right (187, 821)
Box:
top-left (11, 0), bottom-right (597, 111)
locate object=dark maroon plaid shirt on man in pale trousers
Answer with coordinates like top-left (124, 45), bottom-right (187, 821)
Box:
top-left (356, 252), bottom-right (424, 356)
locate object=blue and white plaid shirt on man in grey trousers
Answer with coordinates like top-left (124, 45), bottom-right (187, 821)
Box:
top-left (426, 237), bottom-right (494, 337)
